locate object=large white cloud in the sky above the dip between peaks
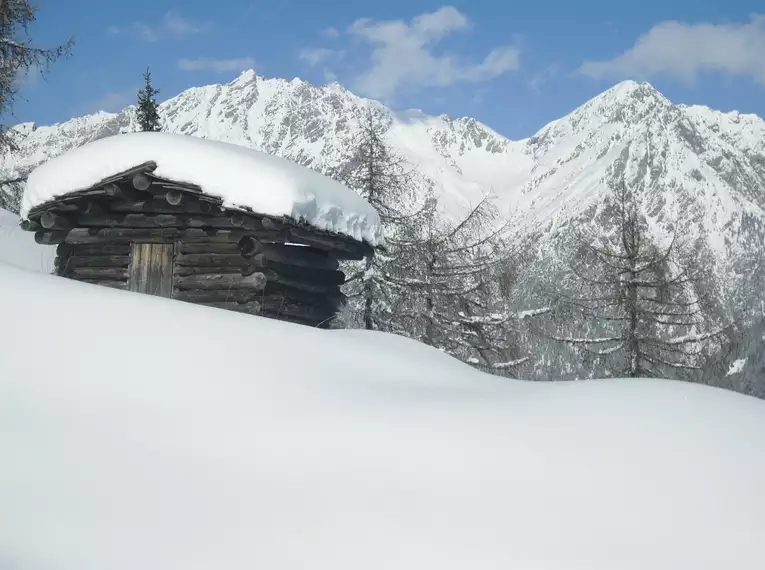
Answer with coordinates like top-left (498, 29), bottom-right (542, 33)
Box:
top-left (348, 6), bottom-right (520, 99)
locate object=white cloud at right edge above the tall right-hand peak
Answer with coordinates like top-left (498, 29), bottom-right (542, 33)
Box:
top-left (579, 14), bottom-right (765, 85)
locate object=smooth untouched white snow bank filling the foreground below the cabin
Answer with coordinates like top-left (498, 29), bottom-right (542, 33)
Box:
top-left (0, 266), bottom-right (765, 570)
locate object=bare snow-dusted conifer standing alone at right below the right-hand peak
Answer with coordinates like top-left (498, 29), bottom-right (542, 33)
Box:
top-left (540, 179), bottom-right (724, 377)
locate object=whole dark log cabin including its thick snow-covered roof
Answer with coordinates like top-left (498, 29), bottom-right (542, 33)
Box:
top-left (21, 132), bottom-right (382, 328)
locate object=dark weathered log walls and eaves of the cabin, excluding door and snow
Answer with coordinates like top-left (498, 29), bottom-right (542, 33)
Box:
top-left (22, 163), bottom-right (374, 328)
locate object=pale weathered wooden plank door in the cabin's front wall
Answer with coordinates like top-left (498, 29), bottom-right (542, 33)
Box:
top-left (128, 243), bottom-right (174, 297)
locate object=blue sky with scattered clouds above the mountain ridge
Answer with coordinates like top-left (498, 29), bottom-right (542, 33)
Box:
top-left (10, 0), bottom-right (765, 138)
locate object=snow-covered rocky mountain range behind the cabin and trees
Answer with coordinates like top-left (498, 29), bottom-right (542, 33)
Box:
top-left (0, 71), bottom-right (765, 310)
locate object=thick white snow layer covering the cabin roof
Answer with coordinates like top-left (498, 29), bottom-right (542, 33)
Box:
top-left (21, 133), bottom-right (383, 245)
